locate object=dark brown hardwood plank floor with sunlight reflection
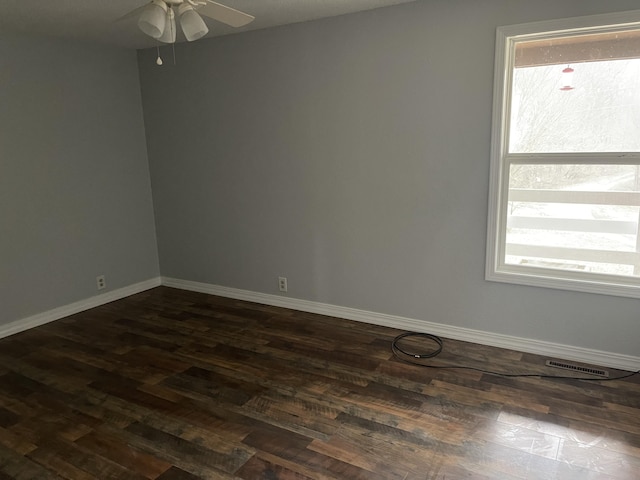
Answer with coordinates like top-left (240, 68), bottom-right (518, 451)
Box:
top-left (0, 287), bottom-right (640, 480)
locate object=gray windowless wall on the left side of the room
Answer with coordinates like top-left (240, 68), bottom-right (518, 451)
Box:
top-left (0, 35), bottom-right (159, 324)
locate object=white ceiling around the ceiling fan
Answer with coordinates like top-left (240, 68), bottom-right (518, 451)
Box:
top-left (0, 0), bottom-right (416, 49)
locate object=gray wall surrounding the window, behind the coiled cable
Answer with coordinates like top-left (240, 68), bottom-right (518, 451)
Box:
top-left (138, 0), bottom-right (640, 355)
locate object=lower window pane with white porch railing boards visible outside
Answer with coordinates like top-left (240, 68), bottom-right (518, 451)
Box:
top-left (505, 165), bottom-right (640, 276)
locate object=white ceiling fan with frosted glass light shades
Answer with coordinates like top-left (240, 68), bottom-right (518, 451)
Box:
top-left (122, 0), bottom-right (255, 43)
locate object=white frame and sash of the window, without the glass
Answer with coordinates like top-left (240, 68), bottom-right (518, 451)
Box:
top-left (485, 10), bottom-right (640, 298)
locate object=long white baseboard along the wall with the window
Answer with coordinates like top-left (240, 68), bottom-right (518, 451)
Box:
top-left (162, 277), bottom-right (640, 372)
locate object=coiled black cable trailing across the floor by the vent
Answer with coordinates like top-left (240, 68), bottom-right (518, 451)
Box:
top-left (391, 332), bottom-right (640, 382)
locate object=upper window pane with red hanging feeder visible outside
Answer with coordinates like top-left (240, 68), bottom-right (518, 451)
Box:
top-left (509, 30), bottom-right (640, 153)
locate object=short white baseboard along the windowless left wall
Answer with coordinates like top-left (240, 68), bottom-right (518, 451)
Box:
top-left (0, 277), bottom-right (160, 338)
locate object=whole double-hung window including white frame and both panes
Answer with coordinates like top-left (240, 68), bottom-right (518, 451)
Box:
top-left (486, 11), bottom-right (640, 298)
